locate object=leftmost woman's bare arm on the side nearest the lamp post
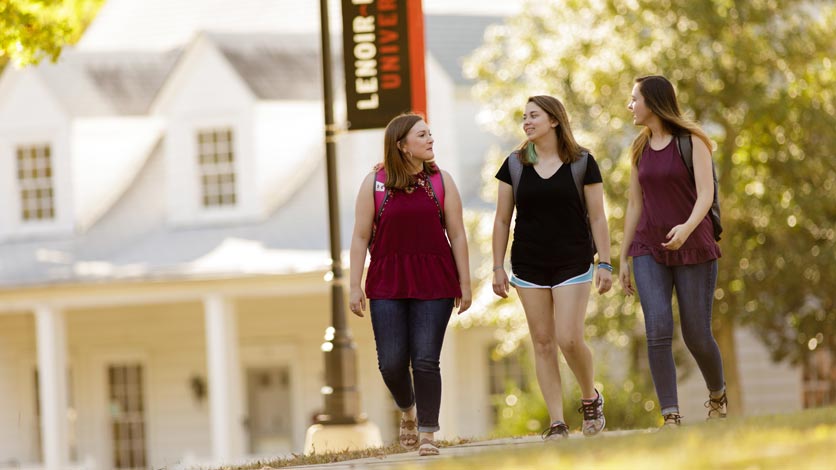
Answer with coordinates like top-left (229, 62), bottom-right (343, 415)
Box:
top-left (349, 173), bottom-right (375, 317)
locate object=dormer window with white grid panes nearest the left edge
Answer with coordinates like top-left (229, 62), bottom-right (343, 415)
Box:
top-left (17, 144), bottom-right (55, 222)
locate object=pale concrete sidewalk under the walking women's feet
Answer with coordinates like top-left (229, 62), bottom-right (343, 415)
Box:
top-left (278, 431), bottom-right (636, 470)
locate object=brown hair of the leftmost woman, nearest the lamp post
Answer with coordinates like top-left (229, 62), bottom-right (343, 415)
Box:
top-left (383, 113), bottom-right (438, 190)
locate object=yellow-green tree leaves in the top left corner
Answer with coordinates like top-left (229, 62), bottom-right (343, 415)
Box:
top-left (0, 0), bottom-right (105, 68)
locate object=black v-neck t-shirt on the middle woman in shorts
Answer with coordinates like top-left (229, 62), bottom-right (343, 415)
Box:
top-left (496, 155), bottom-right (603, 272)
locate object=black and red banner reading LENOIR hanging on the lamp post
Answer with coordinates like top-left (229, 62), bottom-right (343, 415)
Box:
top-left (342, 0), bottom-right (427, 130)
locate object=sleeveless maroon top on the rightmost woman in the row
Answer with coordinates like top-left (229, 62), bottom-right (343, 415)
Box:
top-left (627, 139), bottom-right (720, 266)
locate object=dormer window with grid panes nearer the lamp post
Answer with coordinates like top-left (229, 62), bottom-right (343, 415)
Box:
top-left (197, 128), bottom-right (237, 208)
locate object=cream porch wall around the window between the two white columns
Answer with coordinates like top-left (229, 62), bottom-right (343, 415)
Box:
top-left (67, 303), bottom-right (209, 468)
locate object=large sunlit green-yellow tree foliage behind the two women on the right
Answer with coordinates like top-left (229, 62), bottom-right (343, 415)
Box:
top-left (465, 0), bottom-right (836, 384)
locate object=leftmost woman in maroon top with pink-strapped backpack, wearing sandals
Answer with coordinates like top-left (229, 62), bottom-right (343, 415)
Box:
top-left (342, 114), bottom-right (471, 455)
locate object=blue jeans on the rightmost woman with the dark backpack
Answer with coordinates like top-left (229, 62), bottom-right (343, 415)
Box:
top-left (633, 255), bottom-right (725, 414)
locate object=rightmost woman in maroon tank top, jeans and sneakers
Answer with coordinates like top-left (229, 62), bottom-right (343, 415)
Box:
top-left (619, 75), bottom-right (726, 427)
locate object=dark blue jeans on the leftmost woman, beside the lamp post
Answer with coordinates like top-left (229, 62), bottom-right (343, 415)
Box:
top-left (369, 299), bottom-right (453, 432)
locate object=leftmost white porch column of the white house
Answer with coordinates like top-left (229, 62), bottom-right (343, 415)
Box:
top-left (35, 306), bottom-right (70, 470)
